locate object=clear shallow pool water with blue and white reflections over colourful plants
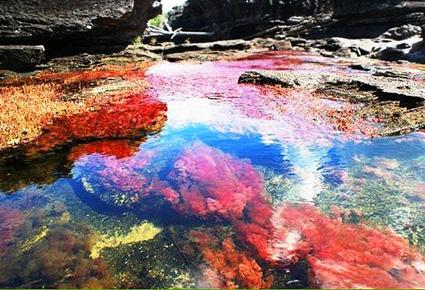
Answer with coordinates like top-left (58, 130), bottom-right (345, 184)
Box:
top-left (0, 54), bottom-right (425, 288)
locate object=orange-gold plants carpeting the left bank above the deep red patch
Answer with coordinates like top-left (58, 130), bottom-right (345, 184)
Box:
top-left (0, 63), bottom-right (150, 149)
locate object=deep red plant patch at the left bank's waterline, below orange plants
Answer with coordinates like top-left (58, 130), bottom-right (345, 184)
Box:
top-left (30, 94), bottom-right (167, 151)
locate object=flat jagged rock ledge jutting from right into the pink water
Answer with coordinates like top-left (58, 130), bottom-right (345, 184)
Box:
top-left (239, 70), bottom-right (425, 136)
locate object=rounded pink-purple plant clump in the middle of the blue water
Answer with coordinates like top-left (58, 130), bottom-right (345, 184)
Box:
top-left (170, 142), bottom-right (263, 220)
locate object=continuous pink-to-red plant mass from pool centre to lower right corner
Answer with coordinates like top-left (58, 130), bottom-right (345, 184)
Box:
top-left (166, 143), bottom-right (425, 288)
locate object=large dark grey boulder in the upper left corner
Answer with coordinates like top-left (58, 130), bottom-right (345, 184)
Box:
top-left (0, 0), bottom-right (160, 53)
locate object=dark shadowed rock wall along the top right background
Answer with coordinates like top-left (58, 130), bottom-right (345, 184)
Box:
top-left (170, 0), bottom-right (425, 38)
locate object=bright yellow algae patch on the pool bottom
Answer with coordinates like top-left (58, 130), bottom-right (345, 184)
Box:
top-left (90, 222), bottom-right (161, 259)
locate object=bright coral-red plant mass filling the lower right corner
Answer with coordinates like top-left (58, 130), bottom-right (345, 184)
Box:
top-left (238, 204), bottom-right (425, 288)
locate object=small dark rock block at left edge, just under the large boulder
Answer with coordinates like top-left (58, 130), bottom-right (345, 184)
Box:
top-left (0, 45), bottom-right (44, 71)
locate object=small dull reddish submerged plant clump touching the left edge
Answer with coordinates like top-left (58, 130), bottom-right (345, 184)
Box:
top-left (0, 206), bottom-right (25, 255)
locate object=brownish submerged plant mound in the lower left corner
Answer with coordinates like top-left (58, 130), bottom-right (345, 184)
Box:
top-left (0, 225), bottom-right (115, 288)
